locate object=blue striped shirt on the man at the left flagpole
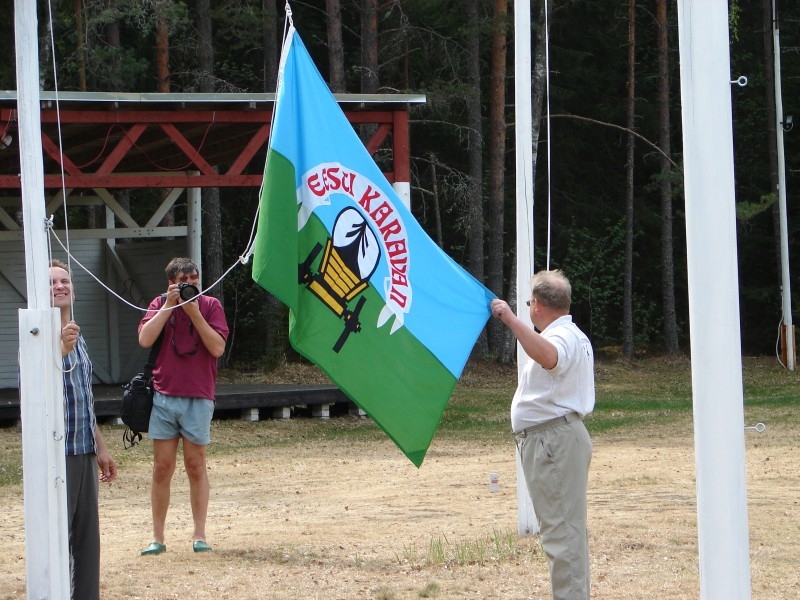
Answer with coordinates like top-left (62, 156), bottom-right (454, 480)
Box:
top-left (63, 335), bottom-right (97, 456)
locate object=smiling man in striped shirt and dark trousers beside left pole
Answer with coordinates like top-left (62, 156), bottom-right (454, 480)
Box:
top-left (50, 261), bottom-right (117, 600)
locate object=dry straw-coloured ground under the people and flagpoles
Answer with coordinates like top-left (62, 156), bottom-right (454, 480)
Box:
top-left (0, 414), bottom-right (800, 600)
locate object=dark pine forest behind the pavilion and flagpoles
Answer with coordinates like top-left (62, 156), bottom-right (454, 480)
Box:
top-left (0, 0), bottom-right (800, 368)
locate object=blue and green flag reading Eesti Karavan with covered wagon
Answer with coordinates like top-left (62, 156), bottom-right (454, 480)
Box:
top-left (253, 28), bottom-right (493, 466)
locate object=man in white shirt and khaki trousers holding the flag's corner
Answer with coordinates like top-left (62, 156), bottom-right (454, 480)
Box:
top-left (491, 271), bottom-right (595, 600)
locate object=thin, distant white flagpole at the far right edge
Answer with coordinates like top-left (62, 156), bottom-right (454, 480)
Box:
top-left (772, 0), bottom-right (795, 371)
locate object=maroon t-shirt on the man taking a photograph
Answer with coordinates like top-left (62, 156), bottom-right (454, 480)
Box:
top-left (139, 296), bottom-right (228, 400)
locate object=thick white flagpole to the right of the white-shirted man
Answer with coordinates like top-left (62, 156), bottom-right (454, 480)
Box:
top-left (678, 0), bottom-right (751, 600)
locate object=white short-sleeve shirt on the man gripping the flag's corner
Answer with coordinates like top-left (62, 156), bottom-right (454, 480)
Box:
top-left (511, 315), bottom-right (595, 431)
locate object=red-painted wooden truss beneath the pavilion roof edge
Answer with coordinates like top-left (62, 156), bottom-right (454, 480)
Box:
top-left (0, 108), bottom-right (410, 189)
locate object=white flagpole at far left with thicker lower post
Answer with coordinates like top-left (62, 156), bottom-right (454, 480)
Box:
top-left (14, 0), bottom-right (70, 600)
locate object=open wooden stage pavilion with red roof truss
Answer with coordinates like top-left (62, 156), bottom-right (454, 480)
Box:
top-left (0, 91), bottom-right (425, 388)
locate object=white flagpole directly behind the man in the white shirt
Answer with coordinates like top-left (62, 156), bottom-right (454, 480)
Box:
top-left (514, 0), bottom-right (539, 534)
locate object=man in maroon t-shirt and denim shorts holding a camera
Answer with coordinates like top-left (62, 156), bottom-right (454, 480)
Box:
top-left (139, 258), bottom-right (228, 555)
